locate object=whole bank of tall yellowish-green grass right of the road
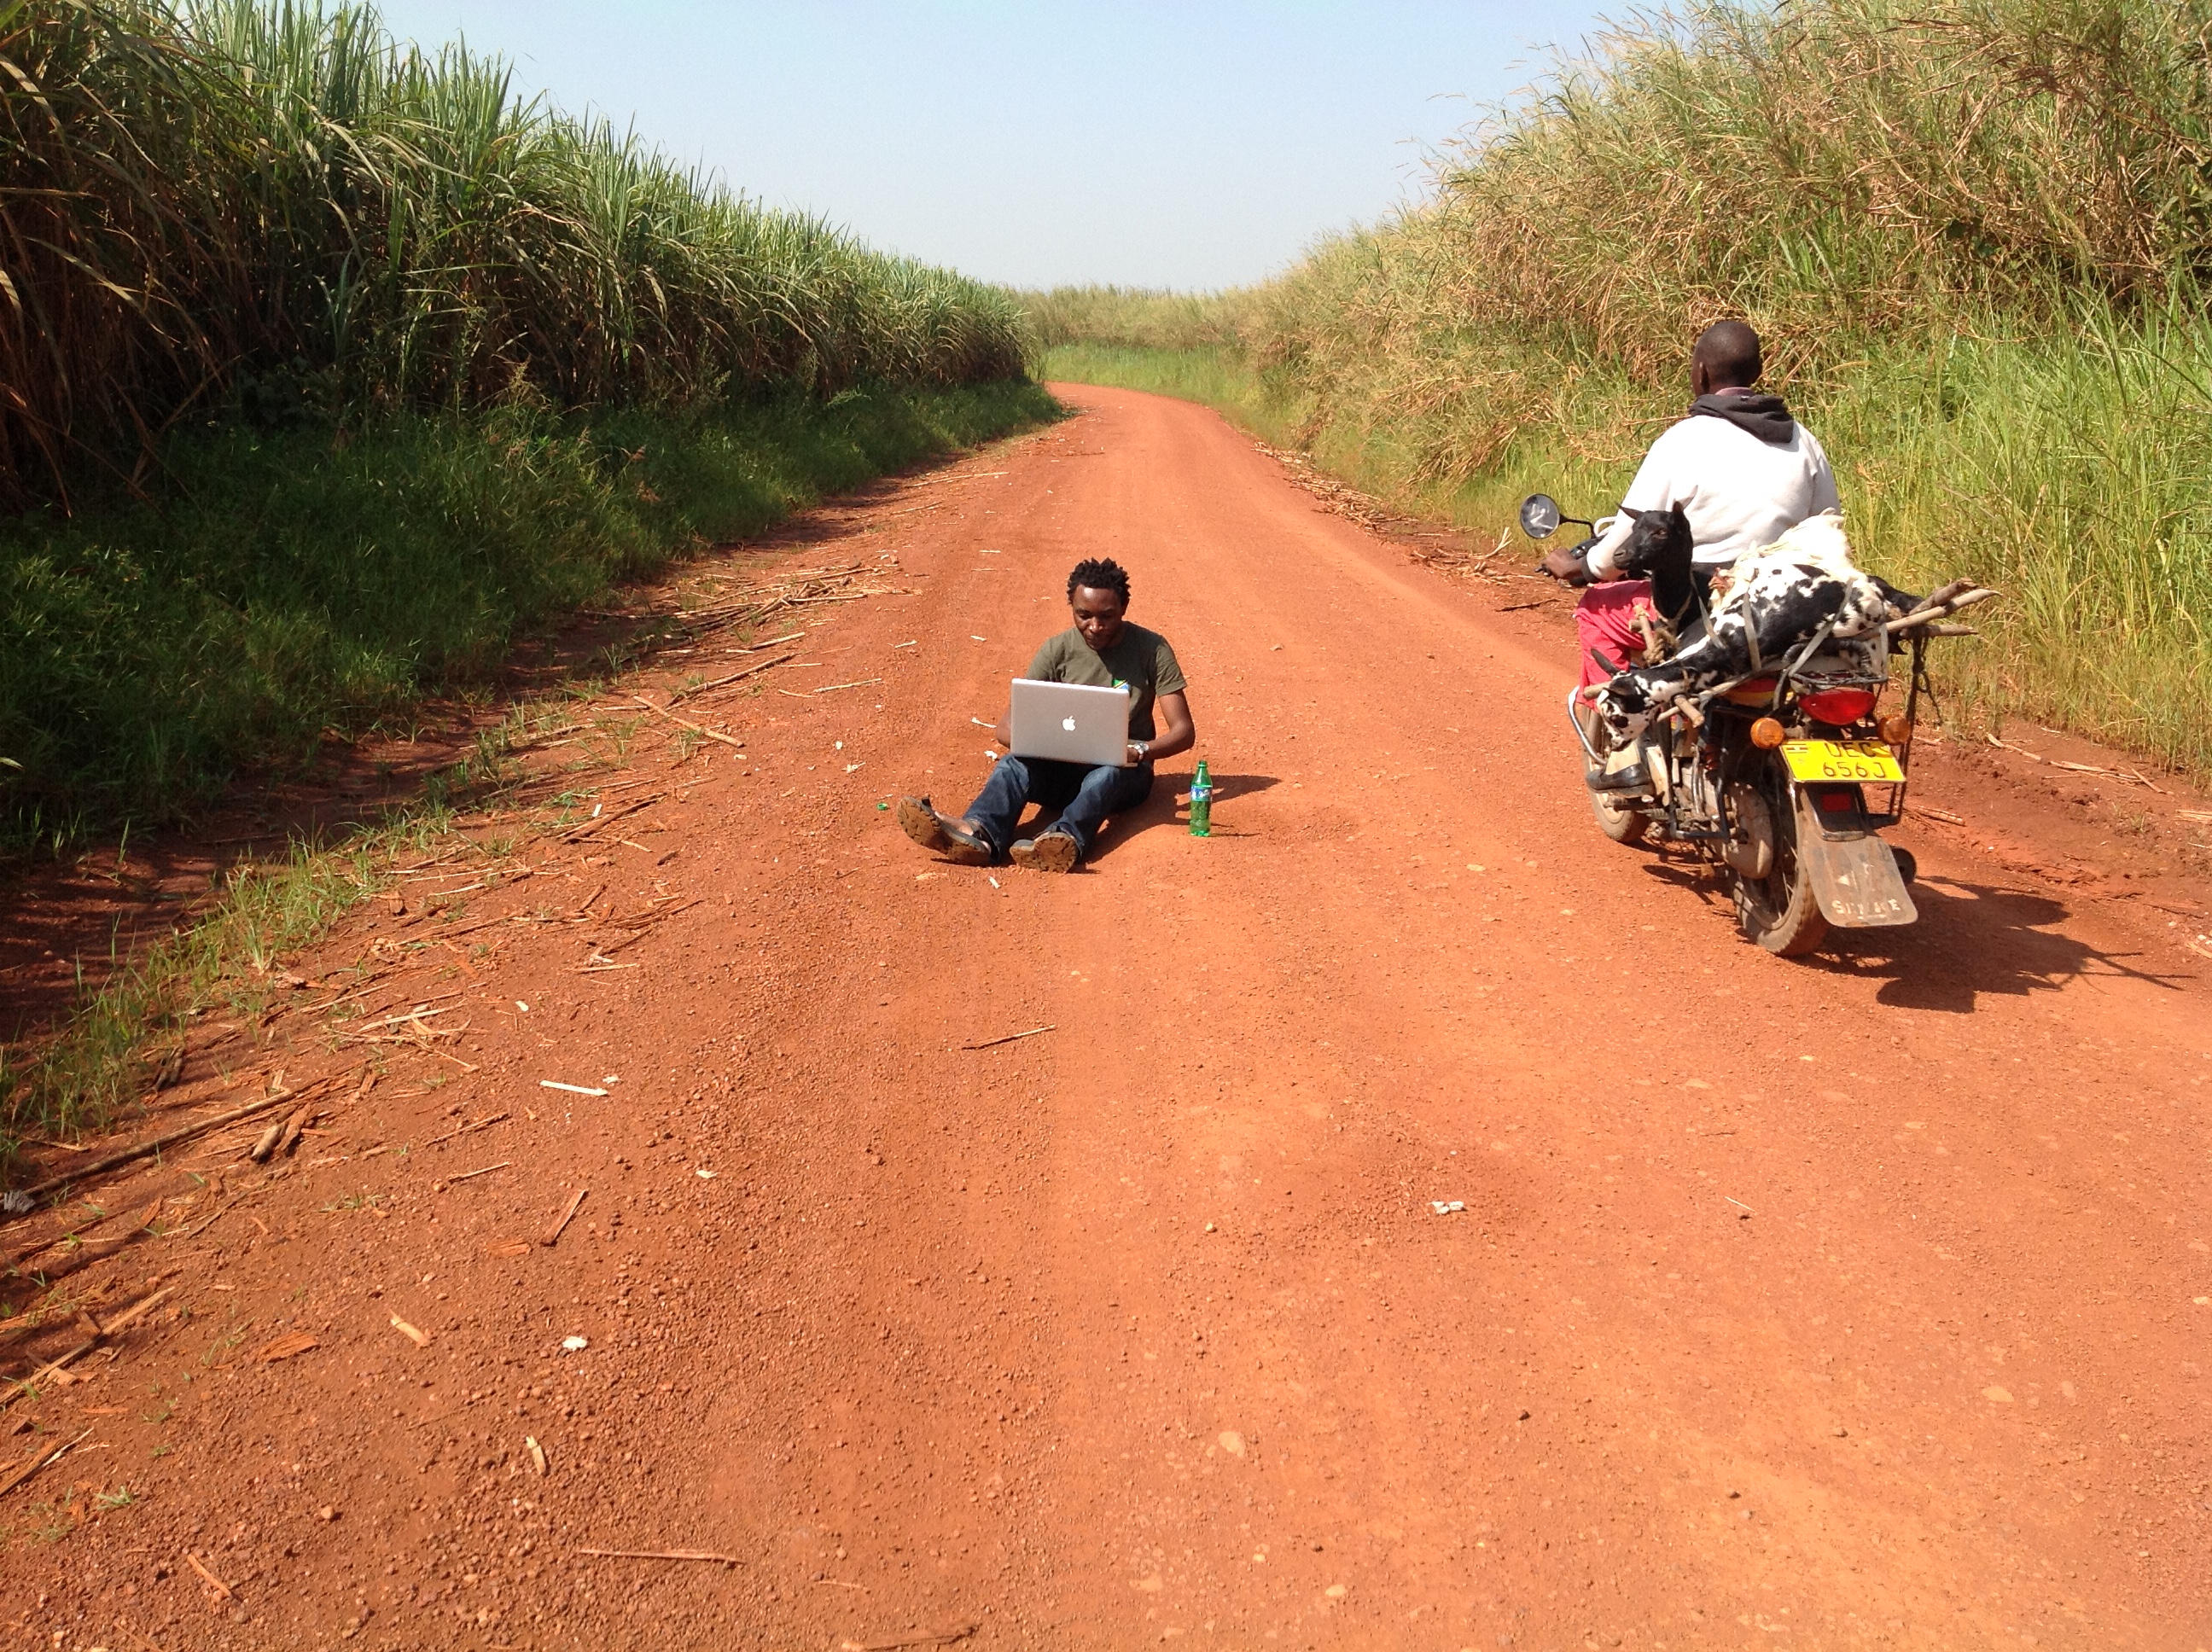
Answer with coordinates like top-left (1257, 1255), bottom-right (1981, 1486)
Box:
top-left (1028, 0), bottom-right (2212, 777)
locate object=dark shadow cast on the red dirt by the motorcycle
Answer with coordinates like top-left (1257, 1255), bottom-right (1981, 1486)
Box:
top-left (1802, 875), bottom-right (2181, 1015)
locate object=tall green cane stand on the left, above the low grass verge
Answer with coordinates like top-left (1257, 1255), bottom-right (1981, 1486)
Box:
top-left (0, 0), bottom-right (1027, 504)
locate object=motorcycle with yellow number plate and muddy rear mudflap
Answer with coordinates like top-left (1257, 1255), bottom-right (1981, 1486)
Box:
top-left (1520, 493), bottom-right (1995, 957)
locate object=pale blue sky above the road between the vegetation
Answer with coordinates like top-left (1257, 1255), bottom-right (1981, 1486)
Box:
top-left (367, 0), bottom-right (1592, 288)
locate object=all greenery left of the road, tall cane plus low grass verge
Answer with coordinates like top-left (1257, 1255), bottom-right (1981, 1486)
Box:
top-left (0, 0), bottom-right (1051, 849)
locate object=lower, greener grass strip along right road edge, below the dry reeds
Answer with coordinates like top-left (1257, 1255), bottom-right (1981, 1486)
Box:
top-left (1044, 335), bottom-right (2212, 781)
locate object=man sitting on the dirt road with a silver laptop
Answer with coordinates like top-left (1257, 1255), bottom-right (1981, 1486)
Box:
top-left (898, 560), bottom-right (1199, 871)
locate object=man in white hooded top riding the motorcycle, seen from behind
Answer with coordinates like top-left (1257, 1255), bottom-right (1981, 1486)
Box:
top-left (1544, 321), bottom-right (1838, 688)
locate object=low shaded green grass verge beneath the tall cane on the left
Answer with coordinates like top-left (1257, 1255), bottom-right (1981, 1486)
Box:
top-left (0, 381), bottom-right (1055, 853)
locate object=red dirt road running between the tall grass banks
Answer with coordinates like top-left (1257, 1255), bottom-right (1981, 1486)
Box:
top-left (0, 387), bottom-right (2212, 1652)
